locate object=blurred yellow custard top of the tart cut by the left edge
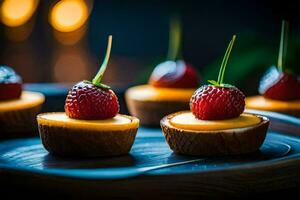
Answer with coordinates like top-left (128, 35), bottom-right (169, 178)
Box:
top-left (0, 91), bottom-right (45, 112)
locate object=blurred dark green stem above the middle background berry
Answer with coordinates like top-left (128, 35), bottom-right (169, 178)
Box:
top-left (167, 16), bottom-right (182, 60)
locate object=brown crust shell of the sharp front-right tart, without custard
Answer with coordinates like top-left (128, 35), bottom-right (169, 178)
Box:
top-left (160, 112), bottom-right (269, 156)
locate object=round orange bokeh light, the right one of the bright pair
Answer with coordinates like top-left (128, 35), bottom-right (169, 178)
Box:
top-left (49, 0), bottom-right (89, 32)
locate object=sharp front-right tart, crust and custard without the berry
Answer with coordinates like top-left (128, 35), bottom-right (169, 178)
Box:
top-left (161, 111), bottom-right (269, 156)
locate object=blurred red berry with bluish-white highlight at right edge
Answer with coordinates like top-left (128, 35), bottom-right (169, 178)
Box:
top-left (258, 67), bottom-right (300, 101)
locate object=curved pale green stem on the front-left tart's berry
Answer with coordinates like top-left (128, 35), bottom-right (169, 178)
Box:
top-left (92, 35), bottom-right (112, 88)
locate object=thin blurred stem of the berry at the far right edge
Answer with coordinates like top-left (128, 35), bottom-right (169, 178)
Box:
top-left (277, 20), bottom-right (289, 72)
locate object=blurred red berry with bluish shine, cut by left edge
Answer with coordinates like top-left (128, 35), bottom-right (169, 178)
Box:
top-left (0, 66), bottom-right (22, 100)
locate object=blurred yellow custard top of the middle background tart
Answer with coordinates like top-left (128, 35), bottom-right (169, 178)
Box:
top-left (126, 85), bottom-right (196, 102)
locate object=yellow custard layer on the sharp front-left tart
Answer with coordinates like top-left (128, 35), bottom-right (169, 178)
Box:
top-left (37, 112), bottom-right (139, 131)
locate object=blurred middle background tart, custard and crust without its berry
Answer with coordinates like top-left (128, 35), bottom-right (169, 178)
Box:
top-left (125, 85), bottom-right (196, 126)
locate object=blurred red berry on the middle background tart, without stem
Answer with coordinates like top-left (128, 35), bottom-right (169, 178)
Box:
top-left (149, 60), bottom-right (199, 88)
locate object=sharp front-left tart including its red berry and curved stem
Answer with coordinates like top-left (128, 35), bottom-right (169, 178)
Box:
top-left (37, 35), bottom-right (139, 157)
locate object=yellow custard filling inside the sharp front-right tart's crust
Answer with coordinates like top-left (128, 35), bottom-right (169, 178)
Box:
top-left (169, 111), bottom-right (261, 131)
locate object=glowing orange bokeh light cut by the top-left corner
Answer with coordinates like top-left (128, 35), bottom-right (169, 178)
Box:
top-left (0, 0), bottom-right (39, 27)
